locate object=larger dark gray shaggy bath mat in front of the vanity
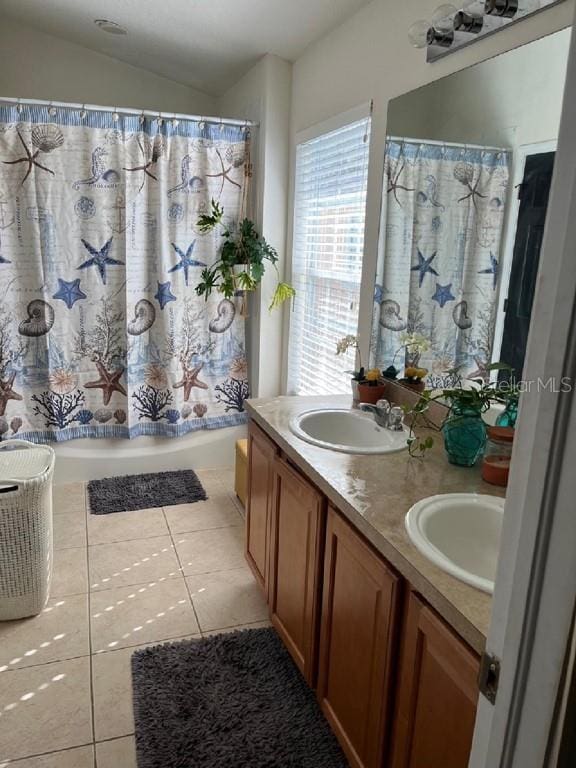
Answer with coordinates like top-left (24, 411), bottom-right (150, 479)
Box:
top-left (132, 629), bottom-right (348, 768)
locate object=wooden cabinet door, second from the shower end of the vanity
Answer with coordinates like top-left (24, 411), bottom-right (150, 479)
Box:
top-left (268, 457), bottom-right (326, 686)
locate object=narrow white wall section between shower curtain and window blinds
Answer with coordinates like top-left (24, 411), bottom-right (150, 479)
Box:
top-left (219, 55), bottom-right (292, 397)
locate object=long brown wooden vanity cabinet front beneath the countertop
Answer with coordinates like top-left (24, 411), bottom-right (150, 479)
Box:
top-left (246, 422), bottom-right (480, 768)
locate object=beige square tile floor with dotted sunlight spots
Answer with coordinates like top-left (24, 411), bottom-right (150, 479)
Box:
top-left (0, 469), bottom-right (268, 768)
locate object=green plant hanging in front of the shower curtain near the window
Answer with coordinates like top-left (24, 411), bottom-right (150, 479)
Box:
top-left (196, 200), bottom-right (296, 310)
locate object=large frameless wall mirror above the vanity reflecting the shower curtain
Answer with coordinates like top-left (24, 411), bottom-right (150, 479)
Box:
top-left (372, 29), bottom-right (570, 389)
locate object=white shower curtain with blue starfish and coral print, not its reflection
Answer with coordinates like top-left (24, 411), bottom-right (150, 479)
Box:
top-left (0, 106), bottom-right (249, 442)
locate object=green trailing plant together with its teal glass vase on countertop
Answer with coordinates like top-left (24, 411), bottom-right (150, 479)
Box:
top-left (404, 363), bottom-right (510, 467)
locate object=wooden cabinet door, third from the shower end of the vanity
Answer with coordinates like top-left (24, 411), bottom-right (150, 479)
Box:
top-left (317, 508), bottom-right (400, 768)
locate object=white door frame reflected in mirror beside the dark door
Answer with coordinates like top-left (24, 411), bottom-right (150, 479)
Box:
top-left (492, 139), bottom-right (558, 366)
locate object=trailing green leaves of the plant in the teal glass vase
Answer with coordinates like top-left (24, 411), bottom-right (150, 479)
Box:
top-left (404, 363), bottom-right (519, 458)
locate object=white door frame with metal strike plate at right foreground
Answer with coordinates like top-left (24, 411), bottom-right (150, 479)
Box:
top-left (469, 15), bottom-right (576, 768)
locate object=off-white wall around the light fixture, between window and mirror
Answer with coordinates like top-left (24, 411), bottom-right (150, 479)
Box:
top-left (284, 0), bottom-right (574, 379)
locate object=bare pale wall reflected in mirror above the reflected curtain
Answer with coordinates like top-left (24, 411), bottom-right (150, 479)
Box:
top-left (387, 29), bottom-right (570, 149)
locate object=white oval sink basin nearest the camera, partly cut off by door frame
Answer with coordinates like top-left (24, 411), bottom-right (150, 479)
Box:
top-left (406, 493), bottom-right (504, 594)
